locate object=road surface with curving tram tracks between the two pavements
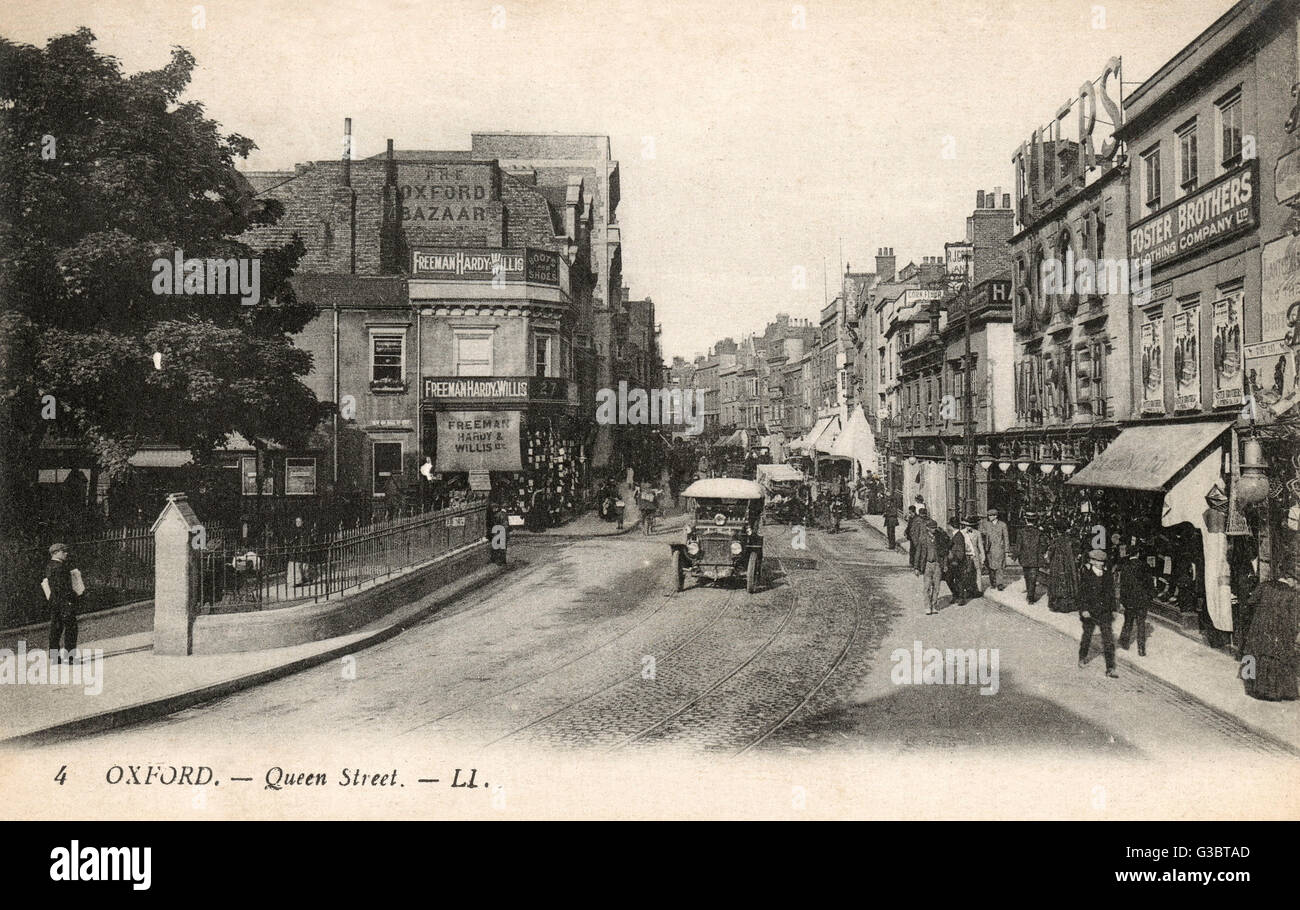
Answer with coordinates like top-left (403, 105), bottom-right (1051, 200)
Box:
top-left (38, 514), bottom-right (1288, 759)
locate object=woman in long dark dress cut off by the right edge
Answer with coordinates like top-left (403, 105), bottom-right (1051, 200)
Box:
top-left (1240, 575), bottom-right (1300, 701)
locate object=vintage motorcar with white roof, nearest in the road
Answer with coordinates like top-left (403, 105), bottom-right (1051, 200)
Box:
top-left (671, 477), bottom-right (763, 594)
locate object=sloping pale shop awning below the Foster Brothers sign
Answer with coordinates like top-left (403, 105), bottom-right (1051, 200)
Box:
top-left (1066, 420), bottom-right (1236, 491)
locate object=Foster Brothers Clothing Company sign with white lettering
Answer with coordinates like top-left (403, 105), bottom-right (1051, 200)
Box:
top-left (1128, 159), bottom-right (1260, 269)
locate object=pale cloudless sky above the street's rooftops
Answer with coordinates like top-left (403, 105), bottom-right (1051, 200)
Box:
top-left (0, 0), bottom-right (1231, 360)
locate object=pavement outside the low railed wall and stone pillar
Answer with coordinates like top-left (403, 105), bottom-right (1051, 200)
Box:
top-left (0, 564), bottom-right (501, 746)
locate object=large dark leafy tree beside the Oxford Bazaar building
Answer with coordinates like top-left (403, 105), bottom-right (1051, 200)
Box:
top-left (0, 29), bottom-right (333, 533)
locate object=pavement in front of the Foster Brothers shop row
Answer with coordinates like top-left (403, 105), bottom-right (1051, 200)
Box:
top-left (862, 515), bottom-right (1300, 753)
